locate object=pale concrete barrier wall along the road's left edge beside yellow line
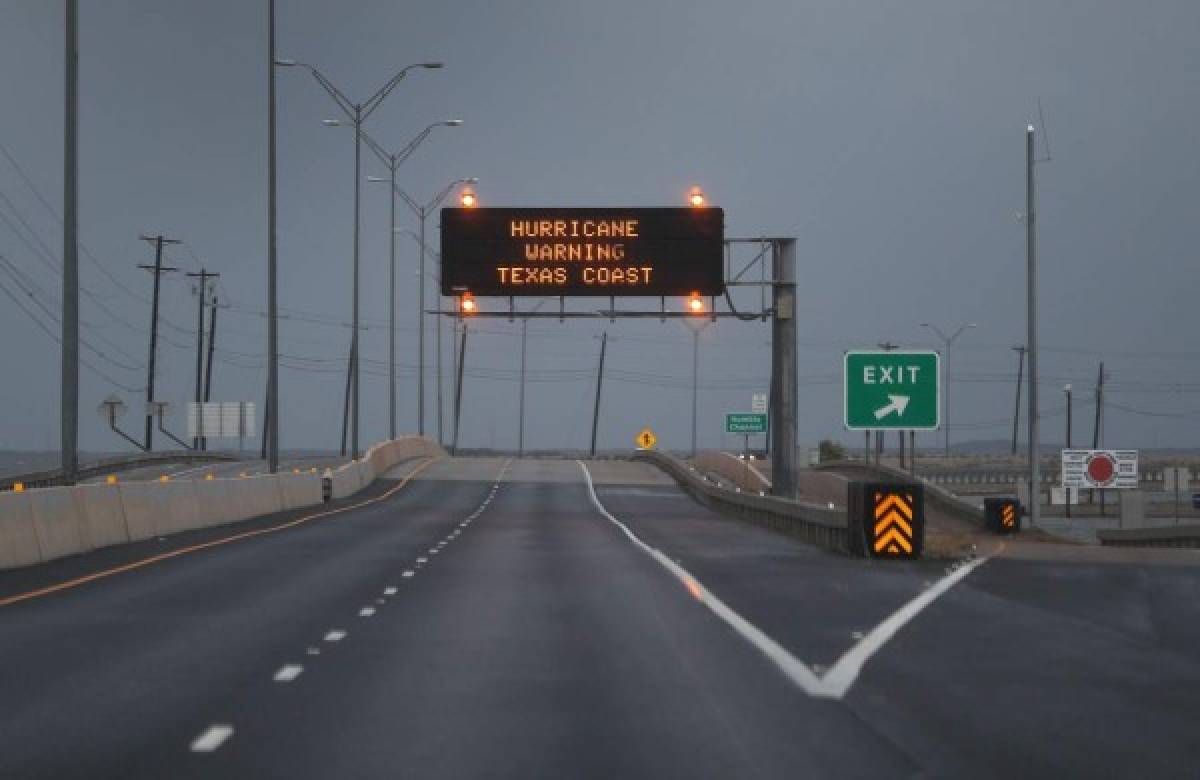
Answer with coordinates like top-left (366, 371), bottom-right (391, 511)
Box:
top-left (0, 436), bottom-right (445, 569)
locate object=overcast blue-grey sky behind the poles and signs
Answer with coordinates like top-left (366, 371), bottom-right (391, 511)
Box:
top-left (0, 0), bottom-right (1200, 449)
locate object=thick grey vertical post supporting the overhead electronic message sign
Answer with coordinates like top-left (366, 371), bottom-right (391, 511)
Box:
top-left (768, 239), bottom-right (798, 498)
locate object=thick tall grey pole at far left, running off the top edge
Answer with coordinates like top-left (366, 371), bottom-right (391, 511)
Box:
top-left (60, 0), bottom-right (79, 485)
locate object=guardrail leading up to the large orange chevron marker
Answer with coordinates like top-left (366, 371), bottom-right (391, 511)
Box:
top-left (632, 450), bottom-right (848, 553)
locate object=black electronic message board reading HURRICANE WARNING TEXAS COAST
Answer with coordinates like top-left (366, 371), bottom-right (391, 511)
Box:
top-left (442, 208), bottom-right (725, 296)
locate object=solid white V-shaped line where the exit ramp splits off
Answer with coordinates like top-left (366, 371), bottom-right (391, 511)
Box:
top-left (576, 461), bottom-right (988, 698)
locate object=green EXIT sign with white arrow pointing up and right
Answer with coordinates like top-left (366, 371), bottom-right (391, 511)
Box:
top-left (842, 349), bottom-right (942, 431)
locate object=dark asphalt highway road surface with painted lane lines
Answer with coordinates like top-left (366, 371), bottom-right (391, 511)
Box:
top-left (0, 458), bottom-right (1200, 780)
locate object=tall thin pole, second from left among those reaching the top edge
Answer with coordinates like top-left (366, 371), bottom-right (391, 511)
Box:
top-left (267, 0), bottom-right (280, 474)
